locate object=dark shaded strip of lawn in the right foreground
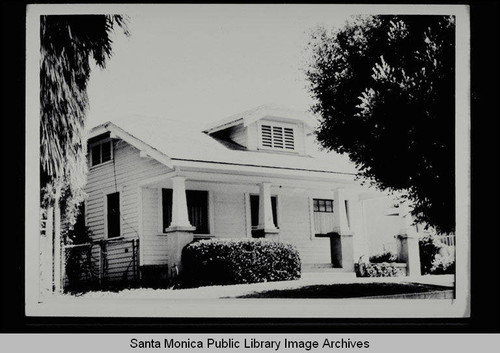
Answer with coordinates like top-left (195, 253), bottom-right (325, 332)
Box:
top-left (232, 283), bottom-right (450, 299)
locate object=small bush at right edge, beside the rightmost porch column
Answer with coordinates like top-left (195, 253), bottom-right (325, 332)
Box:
top-left (419, 237), bottom-right (455, 275)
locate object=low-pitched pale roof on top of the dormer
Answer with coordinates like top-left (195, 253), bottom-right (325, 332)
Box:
top-left (203, 104), bottom-right (315, 134)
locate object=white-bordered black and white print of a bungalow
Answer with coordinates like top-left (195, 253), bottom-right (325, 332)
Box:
top-left (25, 4), bottom-right (471, 319)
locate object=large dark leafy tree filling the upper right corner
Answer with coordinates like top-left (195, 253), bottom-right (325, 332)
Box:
top-left (306, 16), bottom-right (455, 232)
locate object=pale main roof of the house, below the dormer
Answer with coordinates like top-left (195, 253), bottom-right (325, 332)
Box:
top-left (88, 110), bottom-right (357, 174)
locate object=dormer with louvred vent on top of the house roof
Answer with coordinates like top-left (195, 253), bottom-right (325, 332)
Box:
top-left (204, 105), bottom-right (314, 155)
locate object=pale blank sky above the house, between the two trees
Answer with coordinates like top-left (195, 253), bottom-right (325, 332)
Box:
top-left (87, 5), bottom-right (359, 128)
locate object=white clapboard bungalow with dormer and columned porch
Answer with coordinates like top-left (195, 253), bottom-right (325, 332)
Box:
top-left (85, 102), bottom-right (404, 284)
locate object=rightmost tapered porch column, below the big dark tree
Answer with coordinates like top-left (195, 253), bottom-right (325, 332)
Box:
top-left (397, 202), bottom-right (421, 276)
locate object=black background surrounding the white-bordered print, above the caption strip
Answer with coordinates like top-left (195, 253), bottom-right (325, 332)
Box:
top-left (0, 1), bottom-right (500, 333)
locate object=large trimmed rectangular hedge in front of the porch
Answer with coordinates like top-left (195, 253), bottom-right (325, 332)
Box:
top-left (182, 239), bottom-right (301, 287)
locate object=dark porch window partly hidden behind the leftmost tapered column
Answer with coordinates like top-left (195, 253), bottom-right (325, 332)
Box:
top-left (162, 189), bottom-right (210, 234)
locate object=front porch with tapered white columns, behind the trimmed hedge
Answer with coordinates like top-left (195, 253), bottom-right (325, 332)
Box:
top-left (135, 166), bottom-right (366, 272)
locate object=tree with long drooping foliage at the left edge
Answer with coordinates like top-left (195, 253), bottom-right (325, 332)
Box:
top-left (40, 15), bottom-right (129, 227)
